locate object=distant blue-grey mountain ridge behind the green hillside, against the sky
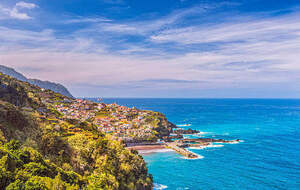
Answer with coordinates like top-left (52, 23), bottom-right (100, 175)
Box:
top-left (0, 65), bottom-right (73, 98)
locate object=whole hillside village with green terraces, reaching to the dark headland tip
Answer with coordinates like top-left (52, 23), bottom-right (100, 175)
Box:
top-left (2, 71), bottom-right (175, 143)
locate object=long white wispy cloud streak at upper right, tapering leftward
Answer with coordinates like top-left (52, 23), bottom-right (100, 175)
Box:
top-left (151, 15), bottom-right (300, 44)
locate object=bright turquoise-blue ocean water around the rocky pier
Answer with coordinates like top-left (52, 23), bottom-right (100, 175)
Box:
top-left (100, 99), bottom-right (300, 190)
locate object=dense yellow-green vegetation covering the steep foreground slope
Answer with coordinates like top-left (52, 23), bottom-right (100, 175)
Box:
top-left (0, 73), bottom-right (152, 190)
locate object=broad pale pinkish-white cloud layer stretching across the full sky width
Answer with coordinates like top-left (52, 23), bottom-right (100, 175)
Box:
top-left (0, 4), bottom-right (300, 95)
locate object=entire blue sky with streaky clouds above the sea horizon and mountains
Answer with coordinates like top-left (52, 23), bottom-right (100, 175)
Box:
top-left (0, 0), bottom-right (300, 98)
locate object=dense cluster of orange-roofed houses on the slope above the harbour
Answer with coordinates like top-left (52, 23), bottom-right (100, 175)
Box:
top-left (47, 99), bottom-right (154, 141)
